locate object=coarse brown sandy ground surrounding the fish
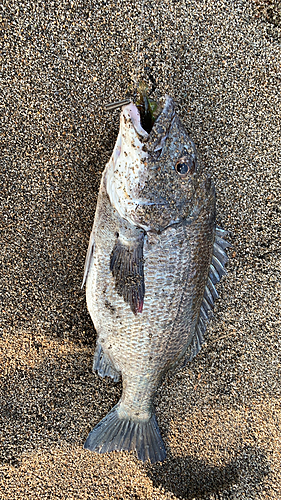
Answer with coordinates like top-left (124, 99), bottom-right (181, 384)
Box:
top-left (0, 0), bottom-right (281, 500)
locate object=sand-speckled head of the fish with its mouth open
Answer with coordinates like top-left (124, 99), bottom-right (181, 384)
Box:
top-left (107, 96), bottom-right (215, 232)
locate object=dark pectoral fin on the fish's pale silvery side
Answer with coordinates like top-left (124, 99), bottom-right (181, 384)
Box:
top-left (110, 234), bottom-right (145, 314)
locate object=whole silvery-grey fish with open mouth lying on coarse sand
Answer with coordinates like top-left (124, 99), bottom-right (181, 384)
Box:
top-left (83, 95), bottom-right (231, 463)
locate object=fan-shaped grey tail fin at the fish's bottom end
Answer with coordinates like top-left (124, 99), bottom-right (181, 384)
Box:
top-left (84, 404), bottom-right (166, 463)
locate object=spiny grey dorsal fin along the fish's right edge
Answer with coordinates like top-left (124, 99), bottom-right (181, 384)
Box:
top-left (189, 227), bottom-right (231, 361)
